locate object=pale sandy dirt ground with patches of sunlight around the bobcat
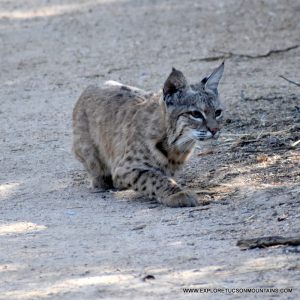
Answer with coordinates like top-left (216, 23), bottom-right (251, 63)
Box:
top-left (0, 0), bottom-right (300, 300)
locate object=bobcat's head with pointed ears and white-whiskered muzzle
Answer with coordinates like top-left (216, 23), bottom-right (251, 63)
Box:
top-left (161, 62), bottom-right (224, 150)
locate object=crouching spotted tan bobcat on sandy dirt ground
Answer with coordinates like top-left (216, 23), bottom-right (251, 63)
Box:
top-left (73, 62), bottom-right (224, 207)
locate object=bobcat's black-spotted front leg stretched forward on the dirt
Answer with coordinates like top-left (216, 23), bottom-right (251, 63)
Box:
top-left (113, 168), bottom-right (198, 207)
